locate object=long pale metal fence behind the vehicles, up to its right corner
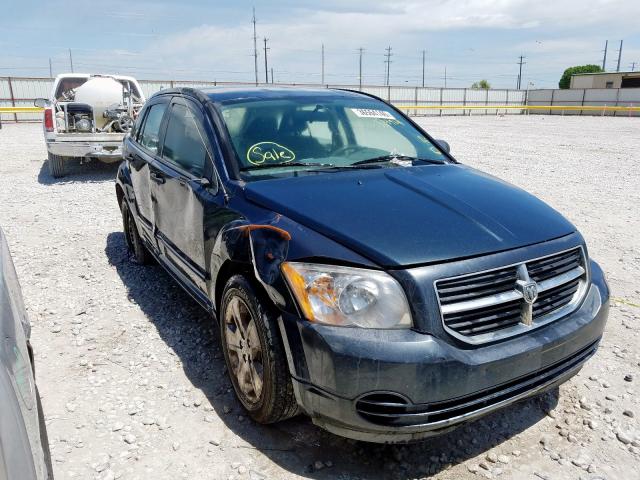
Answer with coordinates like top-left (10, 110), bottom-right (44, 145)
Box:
top-left (0, 77), bottom-right (526, 122)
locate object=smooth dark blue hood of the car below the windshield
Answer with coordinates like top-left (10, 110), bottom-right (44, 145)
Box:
top-left (245, 165), bottom-right (575, 267)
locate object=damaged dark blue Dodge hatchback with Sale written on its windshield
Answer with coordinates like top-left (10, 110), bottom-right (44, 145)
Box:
top-left (116, 88), bottom-right (609, 442)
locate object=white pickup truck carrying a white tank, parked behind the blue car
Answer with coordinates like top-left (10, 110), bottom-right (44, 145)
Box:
top-left (34, 73), bottom-right (145, 178)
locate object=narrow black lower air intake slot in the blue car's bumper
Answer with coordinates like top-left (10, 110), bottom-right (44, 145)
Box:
top-left (355, 341), bottom-right (598, 429)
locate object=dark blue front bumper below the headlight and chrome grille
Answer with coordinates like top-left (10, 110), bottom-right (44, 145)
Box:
top-left (281, 268), bottom-right (609, 443)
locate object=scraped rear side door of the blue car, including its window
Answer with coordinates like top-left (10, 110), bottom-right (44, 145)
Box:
top-left (124, 97), bottom-right (170, 246)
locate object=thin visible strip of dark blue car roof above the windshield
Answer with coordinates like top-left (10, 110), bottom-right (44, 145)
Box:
top-left (197, 86), bottom-right (366, 103)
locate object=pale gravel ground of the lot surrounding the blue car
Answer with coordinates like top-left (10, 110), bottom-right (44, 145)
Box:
top-left (0, 116), bottom-right (640, 480)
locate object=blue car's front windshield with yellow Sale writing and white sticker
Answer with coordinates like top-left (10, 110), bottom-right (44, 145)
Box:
top-left (220, 95), bottom-right (446, 180)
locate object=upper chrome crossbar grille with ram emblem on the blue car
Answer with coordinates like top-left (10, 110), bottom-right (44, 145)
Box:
top-left (435, 247), bottom-right (587, 343)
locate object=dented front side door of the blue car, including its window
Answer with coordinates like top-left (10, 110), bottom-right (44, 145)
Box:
top-left (150, 97), bottom-right (222, 296)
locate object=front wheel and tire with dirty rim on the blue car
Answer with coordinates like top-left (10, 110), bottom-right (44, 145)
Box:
top-left (219, 275), bottom-right (299, 424)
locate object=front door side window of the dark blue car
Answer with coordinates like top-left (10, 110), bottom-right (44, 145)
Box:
top-left (162, 103), bottom-right (207, 176)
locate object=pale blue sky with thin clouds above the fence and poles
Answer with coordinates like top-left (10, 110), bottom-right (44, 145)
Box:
top-left (0, 0), bottom-right (640, 88)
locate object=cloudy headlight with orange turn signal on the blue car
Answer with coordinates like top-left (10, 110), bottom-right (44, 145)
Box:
top-left (282, 262), bottom-right (411, 328)
